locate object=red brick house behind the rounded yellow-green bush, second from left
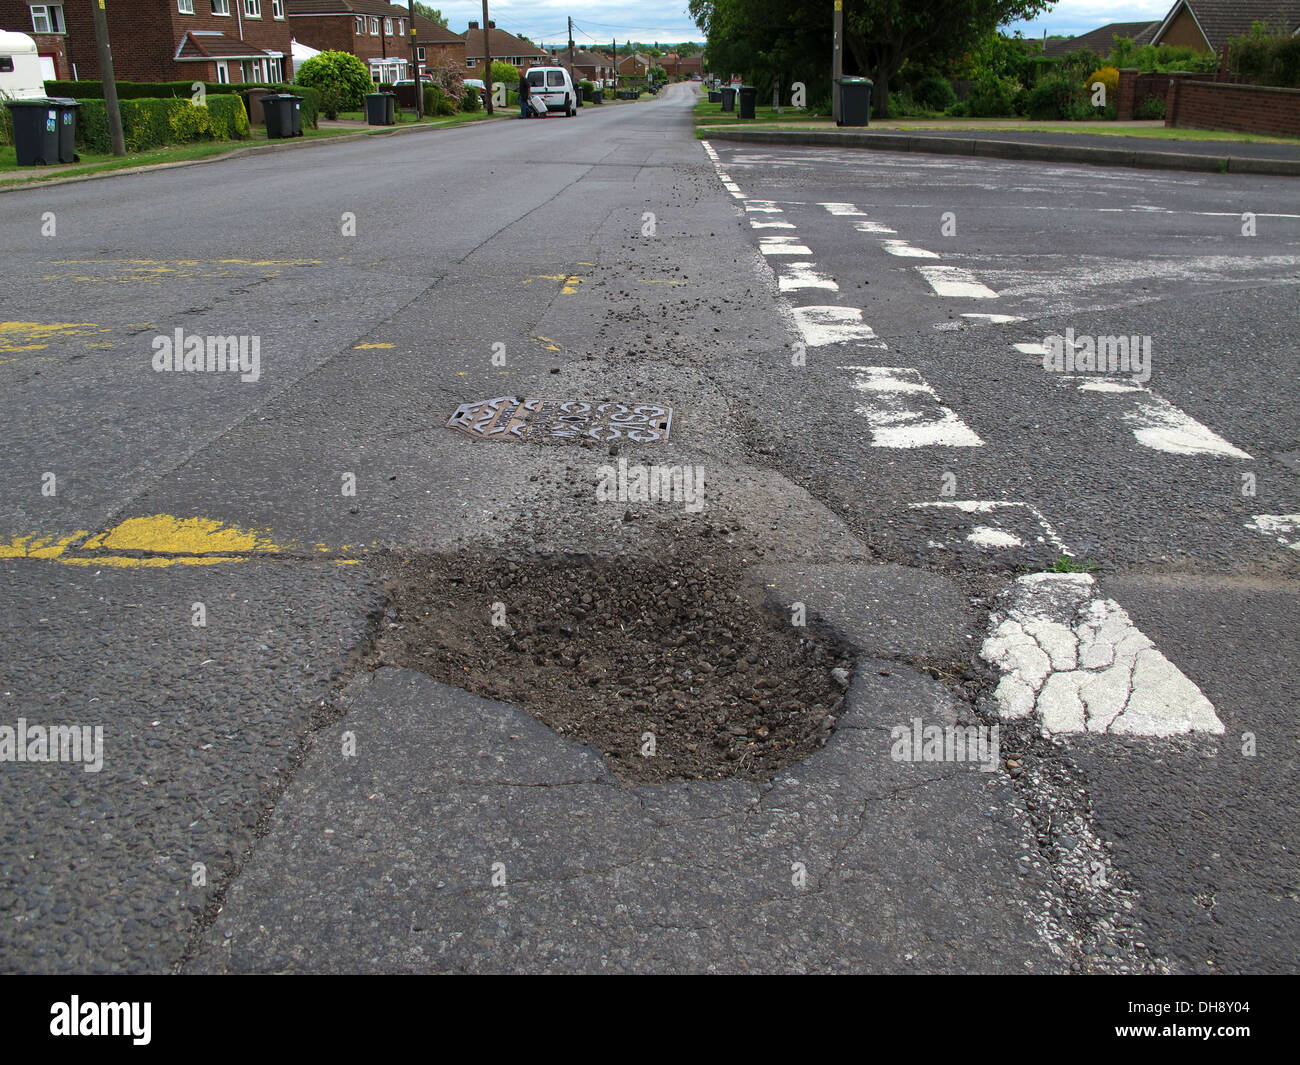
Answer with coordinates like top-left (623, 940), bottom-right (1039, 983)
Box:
top-left (285, 0), bottom-right (436, 83)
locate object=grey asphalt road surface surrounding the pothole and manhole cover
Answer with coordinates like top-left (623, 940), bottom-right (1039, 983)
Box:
top-left (0, 86), bottom-right (1300, 973)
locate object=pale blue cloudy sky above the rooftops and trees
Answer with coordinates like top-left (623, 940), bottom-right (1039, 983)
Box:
top-left (432, 0), bottom-right (1173, 46)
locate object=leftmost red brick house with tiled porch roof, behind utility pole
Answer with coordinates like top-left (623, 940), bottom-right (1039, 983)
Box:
top-left (0, 0), bottom-right (294, 82)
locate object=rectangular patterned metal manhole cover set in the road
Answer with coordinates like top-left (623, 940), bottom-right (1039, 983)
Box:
top-left (447, 395), bottom-right (672, 443)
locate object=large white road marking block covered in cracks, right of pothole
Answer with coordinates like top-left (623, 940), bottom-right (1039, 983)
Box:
top-left (980, 573), bottom-right (1223, 736)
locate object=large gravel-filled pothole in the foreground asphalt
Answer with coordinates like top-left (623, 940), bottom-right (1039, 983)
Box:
top-left (372, 554), bottom-right (854, 783)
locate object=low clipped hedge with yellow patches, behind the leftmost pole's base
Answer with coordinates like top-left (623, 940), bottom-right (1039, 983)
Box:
top-left (77, 95), bottom-right (248, 153)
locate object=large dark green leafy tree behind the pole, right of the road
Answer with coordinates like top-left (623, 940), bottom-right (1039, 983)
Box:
top-left (690, 0), bottom-right (1054, 117)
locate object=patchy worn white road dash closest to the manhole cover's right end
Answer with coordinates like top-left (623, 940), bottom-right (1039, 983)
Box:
top-left (840, 367), bottom-right (984, 447)
